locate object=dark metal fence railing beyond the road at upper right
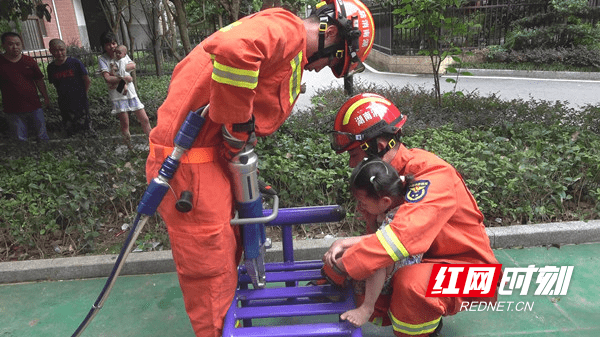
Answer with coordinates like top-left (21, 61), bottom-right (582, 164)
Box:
top-left (369, 0), bottom-right (600, 55)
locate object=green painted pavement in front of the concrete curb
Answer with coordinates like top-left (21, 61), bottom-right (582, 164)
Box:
top-left (0, 243), bottom-right (600, 337)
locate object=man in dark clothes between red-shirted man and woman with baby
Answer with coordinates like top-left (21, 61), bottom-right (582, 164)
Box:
top-left (47, 39), bottom-right (95, 137)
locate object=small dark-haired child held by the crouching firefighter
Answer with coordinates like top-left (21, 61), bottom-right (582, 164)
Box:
top-left (323, 158), bottom-right (422, 326)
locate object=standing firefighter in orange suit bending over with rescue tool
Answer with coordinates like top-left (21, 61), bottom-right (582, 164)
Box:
top-left (146, 0), bottom-right (374, 337)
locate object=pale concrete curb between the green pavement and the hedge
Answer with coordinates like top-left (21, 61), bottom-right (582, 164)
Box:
top-left (0, 220), bottom-right (600, 284)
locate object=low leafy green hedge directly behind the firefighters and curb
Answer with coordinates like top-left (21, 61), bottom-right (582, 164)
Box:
top-left (0, 78), bottom-right (600, 260)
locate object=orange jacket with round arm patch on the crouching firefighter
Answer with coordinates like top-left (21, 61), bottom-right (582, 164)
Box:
top-left (342, 145), bottom-right (498, 280)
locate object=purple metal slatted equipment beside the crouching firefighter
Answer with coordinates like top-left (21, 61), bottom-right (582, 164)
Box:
top-left (223, 205), bottom-right (362, 337)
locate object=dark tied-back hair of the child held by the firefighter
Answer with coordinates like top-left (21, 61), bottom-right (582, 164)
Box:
top-left (350, 158), bottom-right (413, 199)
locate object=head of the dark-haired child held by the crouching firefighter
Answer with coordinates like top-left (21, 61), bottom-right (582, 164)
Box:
top-left (350, 158), bottom-right (412, 215)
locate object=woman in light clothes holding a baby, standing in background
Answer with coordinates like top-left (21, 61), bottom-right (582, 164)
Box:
top-left (98, 31), bottom-right (151, 149)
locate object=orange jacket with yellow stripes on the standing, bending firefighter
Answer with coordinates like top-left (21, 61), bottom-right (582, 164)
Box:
top-left (147, 9), bottom-right (307, 222)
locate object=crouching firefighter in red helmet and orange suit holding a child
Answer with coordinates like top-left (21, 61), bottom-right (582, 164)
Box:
top-left (323, 94), bottom-right (498, 336)
